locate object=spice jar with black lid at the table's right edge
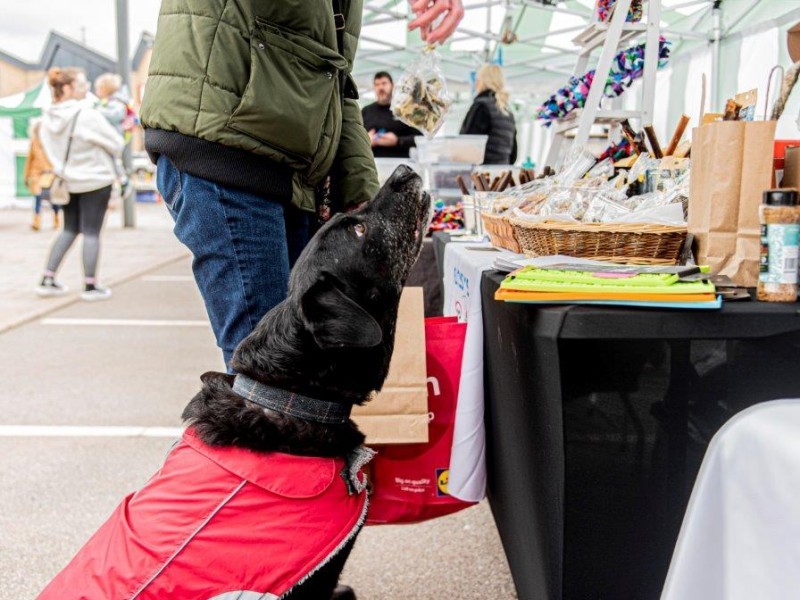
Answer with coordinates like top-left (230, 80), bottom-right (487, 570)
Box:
top-left (757, 189), bottom-right (800, 302)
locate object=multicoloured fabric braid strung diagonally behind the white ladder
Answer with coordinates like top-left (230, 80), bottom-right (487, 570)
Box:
top-left (536, 37), bottom-right (671, 126)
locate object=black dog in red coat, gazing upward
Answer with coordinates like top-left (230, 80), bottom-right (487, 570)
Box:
top-left (41, 167), bottom-right (430, 600)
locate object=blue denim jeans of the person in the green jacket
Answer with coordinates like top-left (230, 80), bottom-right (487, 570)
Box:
top-left (157, 155), bottom-right (310, 365)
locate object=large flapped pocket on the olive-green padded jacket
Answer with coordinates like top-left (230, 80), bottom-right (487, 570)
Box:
top-left (228, 18), bottom-right (347, 166)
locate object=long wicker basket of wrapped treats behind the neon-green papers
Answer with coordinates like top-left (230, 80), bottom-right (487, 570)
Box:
top-left (511, 218), bottom-right (687, 265)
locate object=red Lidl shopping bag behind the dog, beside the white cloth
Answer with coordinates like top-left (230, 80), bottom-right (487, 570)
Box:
top-left (367, 317), bottom-right (473, 525)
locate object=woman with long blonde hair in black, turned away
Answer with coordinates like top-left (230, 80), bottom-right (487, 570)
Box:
top-left (460, 65), bottom-right (517, 165)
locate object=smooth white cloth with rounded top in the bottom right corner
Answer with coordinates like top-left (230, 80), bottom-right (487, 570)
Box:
top-left (662, 400), bottom-right (800, 600)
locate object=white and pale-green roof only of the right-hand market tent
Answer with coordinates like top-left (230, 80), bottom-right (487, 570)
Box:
top-left (355, 0), bottom-right (800, 96)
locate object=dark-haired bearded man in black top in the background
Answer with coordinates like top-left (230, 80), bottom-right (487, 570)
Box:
top-left (361, 71), bottom-right (422, 158)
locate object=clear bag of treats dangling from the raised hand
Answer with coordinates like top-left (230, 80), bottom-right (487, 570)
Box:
top-left (392, 46), bottom-right (452, 137)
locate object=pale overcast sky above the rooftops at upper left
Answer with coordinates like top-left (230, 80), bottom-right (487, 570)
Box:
top-left (0, 0), bottom-right (161, 62)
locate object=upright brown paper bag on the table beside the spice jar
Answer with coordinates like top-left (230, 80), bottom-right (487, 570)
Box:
top-left (689, 121), bottom-right (775, 287)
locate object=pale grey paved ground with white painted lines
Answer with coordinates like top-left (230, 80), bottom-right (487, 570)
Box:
top-left (0, 206), bottom-right (516, 600)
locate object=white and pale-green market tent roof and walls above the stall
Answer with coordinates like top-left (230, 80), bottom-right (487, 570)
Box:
top-left (355, 0), bottom-right (800, 164)
